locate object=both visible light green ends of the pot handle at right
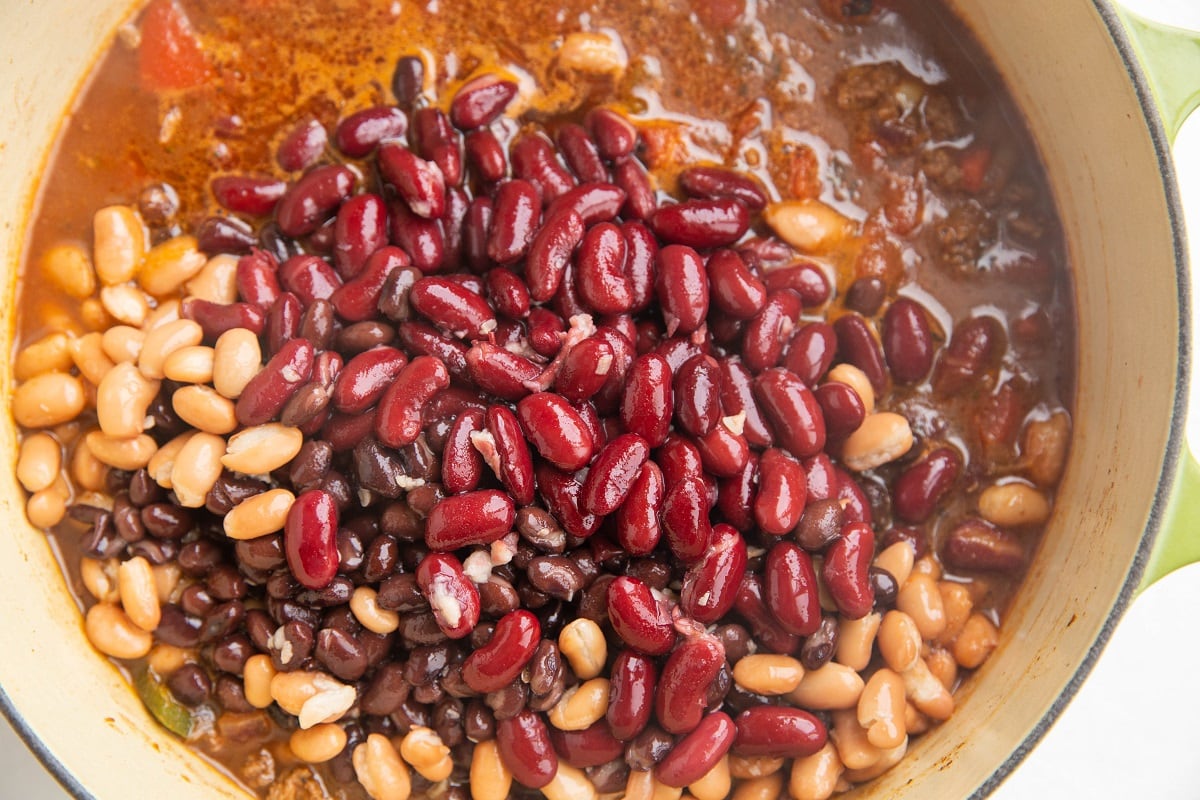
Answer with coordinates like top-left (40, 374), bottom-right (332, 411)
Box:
top-left (1117, 6), bottom-right (1200, 591)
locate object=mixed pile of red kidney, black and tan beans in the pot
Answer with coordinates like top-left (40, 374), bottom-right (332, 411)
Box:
top-left (13, 43), bottom-right (1067, 800)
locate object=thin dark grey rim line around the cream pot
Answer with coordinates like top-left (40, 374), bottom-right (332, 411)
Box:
top-left (0, 0), bottom-right (1193, 800)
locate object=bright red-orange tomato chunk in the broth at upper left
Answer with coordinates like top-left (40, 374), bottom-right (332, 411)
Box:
top-left (138, 0), bottom-right (212, 91)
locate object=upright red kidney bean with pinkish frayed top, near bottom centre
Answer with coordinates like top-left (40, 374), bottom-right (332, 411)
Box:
top-left (654, 633), bottom-right (725, 734)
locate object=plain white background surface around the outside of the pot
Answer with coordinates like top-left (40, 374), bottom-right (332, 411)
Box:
top-left (0, 0), bottom-right (1200, 800)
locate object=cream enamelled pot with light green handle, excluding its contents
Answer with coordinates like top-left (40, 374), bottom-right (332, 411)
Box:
top-left (0, 0), bottom-right (1200, 800)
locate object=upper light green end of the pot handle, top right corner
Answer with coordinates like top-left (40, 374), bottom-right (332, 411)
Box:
top-left (1116, 5), bottom-right (1200, 142)
